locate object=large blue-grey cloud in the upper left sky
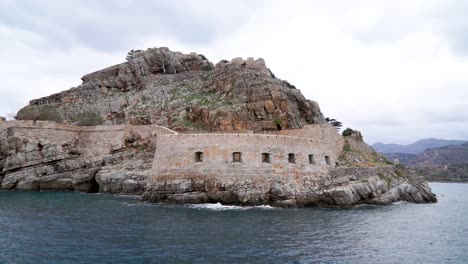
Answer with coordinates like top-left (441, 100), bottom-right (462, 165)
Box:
top-left (0, 0), bottom-right (256, 52)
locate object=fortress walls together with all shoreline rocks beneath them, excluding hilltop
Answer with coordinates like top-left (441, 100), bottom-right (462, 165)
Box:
top-left (0, 116), bottom-right (437, 207)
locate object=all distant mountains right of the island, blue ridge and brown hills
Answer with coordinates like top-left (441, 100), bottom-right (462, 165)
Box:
top-left (372, 139), bottom-right (468, 182)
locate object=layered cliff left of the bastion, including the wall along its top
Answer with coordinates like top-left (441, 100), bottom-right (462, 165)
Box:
top-left (0, 121), bottom-right (166, 194)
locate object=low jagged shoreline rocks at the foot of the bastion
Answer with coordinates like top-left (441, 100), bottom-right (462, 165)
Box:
top-left (143, 166), bottom-right (437, 207)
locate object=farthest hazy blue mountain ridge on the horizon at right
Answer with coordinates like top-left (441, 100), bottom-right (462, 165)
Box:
top-left (372, 138), bottom-right (468, 154)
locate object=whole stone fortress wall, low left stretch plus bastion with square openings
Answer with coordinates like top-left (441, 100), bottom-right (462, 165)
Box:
top-left (0, 121), bottom-right (343, 184)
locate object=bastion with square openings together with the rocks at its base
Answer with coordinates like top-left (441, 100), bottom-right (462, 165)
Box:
top-left (143, 125), bottom-right (436, 207)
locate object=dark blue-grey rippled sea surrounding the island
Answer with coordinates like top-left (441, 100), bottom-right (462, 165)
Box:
top-left (0, 183), bottom-right (468, 263)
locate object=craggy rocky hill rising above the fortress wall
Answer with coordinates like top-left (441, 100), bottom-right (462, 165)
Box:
top-left (18, 48), bottom-right (324, 131)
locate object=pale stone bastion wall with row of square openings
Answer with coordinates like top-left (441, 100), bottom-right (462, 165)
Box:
top-left (151, 125), bottom-right (344, 180)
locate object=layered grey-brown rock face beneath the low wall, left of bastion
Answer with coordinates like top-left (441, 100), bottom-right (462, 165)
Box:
top-left (0, 123), bottom-right (154, 194)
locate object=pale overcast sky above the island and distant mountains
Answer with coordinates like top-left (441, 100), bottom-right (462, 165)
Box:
top-left (0, 0), bottom-right (468, 143)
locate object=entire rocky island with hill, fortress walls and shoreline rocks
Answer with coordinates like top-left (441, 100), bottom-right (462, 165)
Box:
top-left (0, 48), bottom-right (437, 207)
